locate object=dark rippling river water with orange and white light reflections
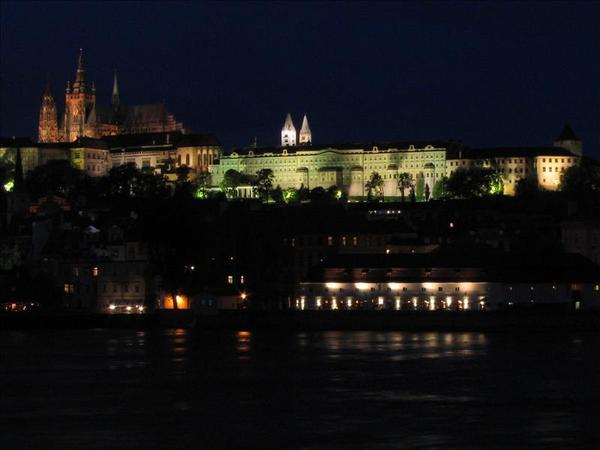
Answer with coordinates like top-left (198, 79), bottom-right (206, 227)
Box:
top-left (0, 328), bottom-right (600, 450)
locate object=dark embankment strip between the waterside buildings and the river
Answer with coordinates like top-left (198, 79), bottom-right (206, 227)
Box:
top-left (0, 310), bottom-right (600, 332)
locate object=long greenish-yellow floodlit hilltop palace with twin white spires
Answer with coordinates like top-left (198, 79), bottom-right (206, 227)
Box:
top-left (210, 118), bottom-right (581, 197)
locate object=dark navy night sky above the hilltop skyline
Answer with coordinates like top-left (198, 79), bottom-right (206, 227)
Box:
top-left (0, 1), bottom-right (600, 156)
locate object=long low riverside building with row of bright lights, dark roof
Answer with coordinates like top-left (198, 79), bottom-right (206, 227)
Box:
top-left (293, 251), bottom-right (600, 311)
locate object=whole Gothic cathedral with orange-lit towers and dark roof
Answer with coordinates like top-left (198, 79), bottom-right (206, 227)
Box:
top-left (38, 49), bottom-right (184, 142)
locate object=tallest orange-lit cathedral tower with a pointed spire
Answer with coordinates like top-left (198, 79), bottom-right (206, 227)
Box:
top-left (64, 49), bottom-right (97, 142)
